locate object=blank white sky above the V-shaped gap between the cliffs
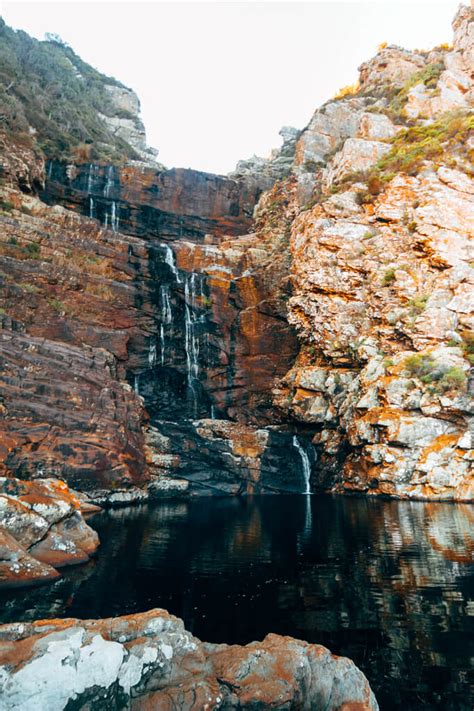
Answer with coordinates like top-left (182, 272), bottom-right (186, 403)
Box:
top-left (0, 0), bottom-right (459, 173)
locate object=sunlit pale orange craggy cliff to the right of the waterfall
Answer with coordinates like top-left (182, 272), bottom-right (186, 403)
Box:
top-left (275, 2), bottom-right (474, 501)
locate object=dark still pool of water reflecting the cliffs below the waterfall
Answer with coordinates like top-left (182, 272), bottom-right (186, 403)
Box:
top-left (0, 496), bottom-right (474, 711)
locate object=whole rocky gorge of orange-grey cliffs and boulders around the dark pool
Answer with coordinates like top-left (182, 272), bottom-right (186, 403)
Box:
top-left (0, 6), bottom-right (474, 711)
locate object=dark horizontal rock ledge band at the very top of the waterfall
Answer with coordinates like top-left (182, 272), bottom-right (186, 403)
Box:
top-left (41, 162), bottom-right (261, 242)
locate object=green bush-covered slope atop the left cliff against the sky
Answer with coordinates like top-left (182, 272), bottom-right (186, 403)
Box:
top-left (0, 18), bottom-right (138, 162)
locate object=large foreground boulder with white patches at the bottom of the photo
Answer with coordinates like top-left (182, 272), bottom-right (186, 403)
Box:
top-left (0, 610), bottom-right (378, 711)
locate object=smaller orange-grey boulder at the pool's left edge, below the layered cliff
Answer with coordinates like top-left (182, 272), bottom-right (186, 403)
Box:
top-left (0, 477), bottom-right (99, 588)
